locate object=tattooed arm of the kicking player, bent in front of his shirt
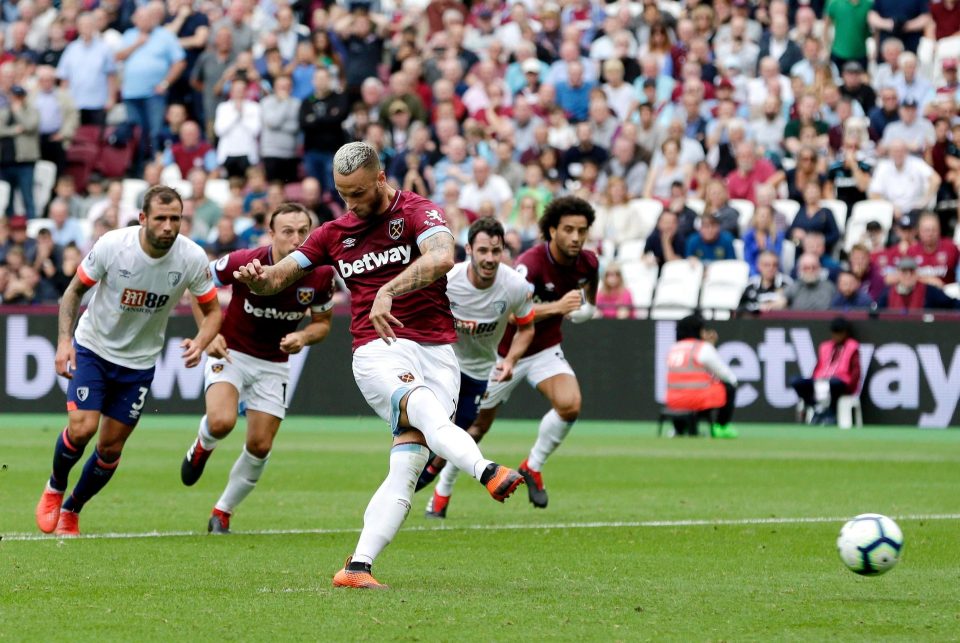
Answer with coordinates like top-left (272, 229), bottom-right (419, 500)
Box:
top-left (370, 232), bottom-right (454, 344)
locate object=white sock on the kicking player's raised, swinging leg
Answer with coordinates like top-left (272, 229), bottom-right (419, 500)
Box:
top-left (407, 386), bottom-right (492, 480)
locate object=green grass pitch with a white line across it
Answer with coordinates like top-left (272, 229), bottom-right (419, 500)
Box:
top-left (0, 415), bottom-right (960, 641)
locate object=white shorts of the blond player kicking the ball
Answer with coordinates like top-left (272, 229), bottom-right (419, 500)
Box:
top-left (353, 339), bottom-right (460, 435)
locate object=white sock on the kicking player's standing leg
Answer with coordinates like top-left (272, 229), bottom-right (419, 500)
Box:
top-left (353, 444), bottom-right (430, 565)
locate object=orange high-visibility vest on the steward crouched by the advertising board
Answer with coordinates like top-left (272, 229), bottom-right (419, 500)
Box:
top-left (667, 339), bottom-right (727, 411)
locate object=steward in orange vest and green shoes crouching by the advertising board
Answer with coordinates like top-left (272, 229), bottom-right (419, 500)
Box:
top-left (666, 315), bottom-right (737, 438)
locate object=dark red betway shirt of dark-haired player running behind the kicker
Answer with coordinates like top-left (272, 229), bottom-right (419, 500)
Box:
top-left (210, 246), bottom-right (336, 362)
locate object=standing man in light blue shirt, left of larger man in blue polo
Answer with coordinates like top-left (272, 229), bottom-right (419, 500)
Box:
top-left (57, 13), bottom-right (117, 125)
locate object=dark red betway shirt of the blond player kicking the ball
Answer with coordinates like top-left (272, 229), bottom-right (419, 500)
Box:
top-left (291, 190), bottom-right (457, 349)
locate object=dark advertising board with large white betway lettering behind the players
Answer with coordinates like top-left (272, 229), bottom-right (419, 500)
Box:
top-left (0, 308), bottom-right (960, 428)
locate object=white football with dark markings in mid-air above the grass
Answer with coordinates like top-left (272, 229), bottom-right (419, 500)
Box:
top-left (837, 514), bottom-right (903, 576)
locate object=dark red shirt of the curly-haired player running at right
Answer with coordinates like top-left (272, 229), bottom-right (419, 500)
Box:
top-left (497, 243), bottom-right (599, 357)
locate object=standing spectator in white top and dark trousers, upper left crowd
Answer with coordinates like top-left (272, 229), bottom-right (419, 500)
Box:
top-left (213, 78), bottom-right (262, 177)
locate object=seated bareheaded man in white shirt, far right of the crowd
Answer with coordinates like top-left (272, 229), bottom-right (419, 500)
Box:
top-left (868, 139), bottom-right (940, 216)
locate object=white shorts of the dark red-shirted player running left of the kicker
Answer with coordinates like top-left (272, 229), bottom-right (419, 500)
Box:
top-left (203, 350), bottom-right (290, 420)
